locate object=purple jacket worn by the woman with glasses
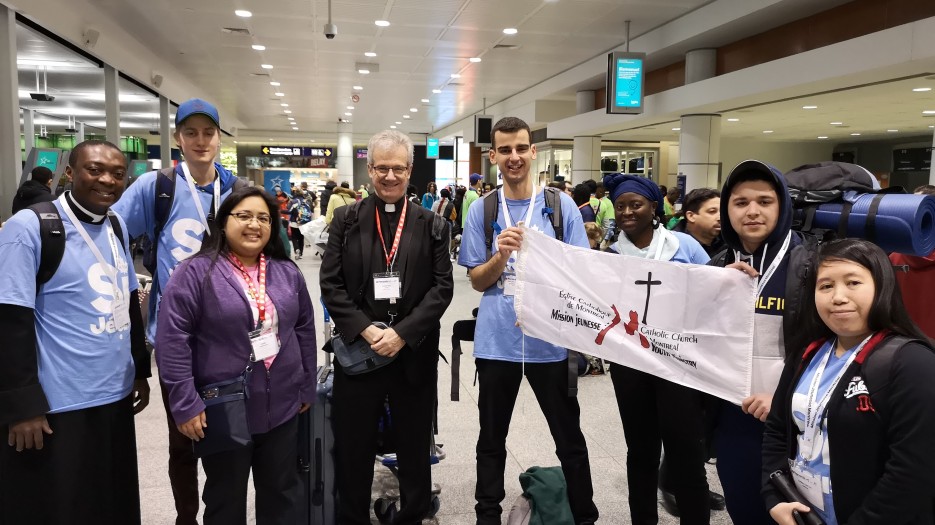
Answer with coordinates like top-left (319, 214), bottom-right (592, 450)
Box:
top-left (155, 257), bottom-right (317, 434)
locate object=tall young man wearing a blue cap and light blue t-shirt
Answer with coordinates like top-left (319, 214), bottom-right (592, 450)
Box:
top-left (113, 98), bottom-right (245, 525)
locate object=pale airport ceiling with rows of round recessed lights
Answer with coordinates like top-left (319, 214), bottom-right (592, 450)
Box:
top-left (16, 0), bottom-right (935, 144)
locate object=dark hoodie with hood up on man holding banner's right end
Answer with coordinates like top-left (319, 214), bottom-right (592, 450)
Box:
top-left (708, 160), bottom-right (802, 394)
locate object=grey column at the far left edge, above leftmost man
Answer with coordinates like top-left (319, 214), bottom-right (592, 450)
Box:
top-left (0, 5), bottom-right (23, 220)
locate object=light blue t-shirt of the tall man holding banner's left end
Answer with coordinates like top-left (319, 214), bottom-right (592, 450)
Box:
top-left (458, 190), bottom-right (590, 363)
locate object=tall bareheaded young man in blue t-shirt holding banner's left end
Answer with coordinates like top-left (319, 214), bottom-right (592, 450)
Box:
top-left (458, 117), bottom-right (598, 525)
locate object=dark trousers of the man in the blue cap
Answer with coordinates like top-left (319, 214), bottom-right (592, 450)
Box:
top-left (159, 381), bottom-right (199, 525)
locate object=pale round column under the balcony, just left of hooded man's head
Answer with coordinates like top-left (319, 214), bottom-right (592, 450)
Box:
top-left (679, 113), bottom-right (721, 193)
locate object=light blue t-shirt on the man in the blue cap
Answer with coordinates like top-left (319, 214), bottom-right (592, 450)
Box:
top-left (112, 164), bottom-right (234, 343)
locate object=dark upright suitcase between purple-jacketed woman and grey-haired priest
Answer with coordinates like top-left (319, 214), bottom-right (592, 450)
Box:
top-left (299, 365), bottom-right (337, 525)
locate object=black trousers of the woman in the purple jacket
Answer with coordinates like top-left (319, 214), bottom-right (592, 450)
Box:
top-left (201, 417), bottom-right (299, 525)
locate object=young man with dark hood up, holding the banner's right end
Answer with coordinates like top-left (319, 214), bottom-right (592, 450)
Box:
top-left (708, 160), bottom-right (802, 525)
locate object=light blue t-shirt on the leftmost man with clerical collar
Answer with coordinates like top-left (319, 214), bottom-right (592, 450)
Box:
top-left (0, 196), bottom-right (138, 412)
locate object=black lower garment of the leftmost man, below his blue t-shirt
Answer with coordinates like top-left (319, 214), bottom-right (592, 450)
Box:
top-left (0, 396), bottom-right (140, 525)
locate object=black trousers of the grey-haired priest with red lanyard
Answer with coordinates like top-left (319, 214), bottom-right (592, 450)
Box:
top-left (332, 354), bottom-right (438, 525)
